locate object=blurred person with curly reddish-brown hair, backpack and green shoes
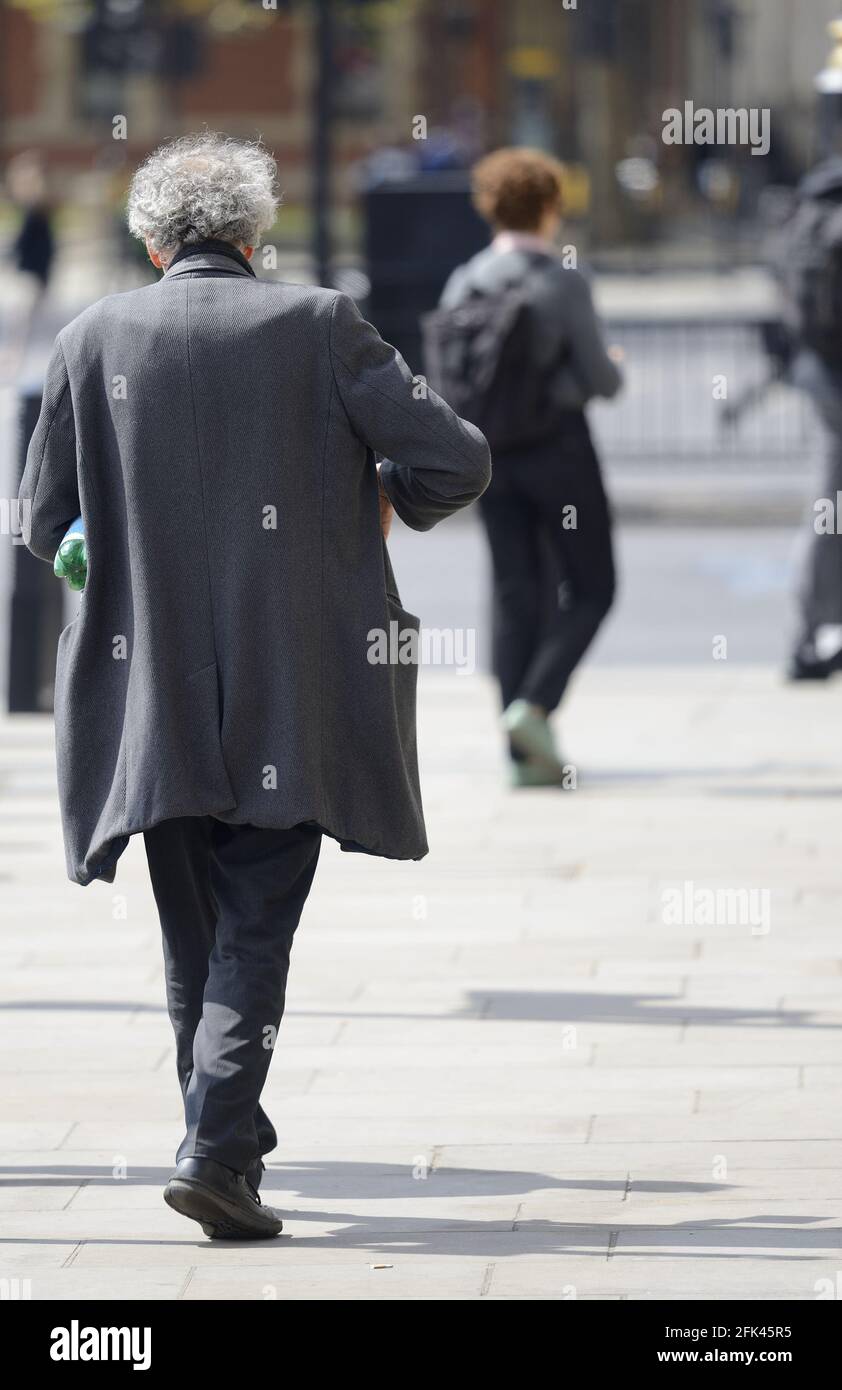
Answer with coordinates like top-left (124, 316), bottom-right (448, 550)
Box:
top-left (422, 149), bottom-right (621, 787)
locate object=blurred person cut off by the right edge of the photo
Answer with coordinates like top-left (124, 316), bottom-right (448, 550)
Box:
top-left (774, 157), bottom-right (842, 680)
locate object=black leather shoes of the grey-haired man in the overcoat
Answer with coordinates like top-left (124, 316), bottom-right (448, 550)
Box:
top-left (164, 1158), bottom-right (283, 1240)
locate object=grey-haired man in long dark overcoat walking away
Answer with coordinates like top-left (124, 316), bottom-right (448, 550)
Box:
top-left (21, 133), bottom-right (489, 1238)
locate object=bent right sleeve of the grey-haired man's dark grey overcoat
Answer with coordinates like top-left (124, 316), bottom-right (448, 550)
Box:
top-left (331, 295), bottom-right (490, 531)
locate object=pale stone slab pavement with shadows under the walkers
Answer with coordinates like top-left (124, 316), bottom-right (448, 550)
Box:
top-left (0, 662), bottom-right (842, 1300)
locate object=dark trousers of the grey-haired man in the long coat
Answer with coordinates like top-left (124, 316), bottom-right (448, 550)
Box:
top-left (145, 816), bottom-right (321, 1187)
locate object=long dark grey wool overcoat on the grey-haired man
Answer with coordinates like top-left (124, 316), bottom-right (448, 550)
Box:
top-left (21, 250), bottom-right (489, 884)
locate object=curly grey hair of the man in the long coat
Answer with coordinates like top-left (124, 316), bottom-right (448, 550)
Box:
top-left (126, 131), bottom-right (279, 252)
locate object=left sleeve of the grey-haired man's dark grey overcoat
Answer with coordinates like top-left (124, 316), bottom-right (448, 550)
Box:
top-left (18, 338), bottom-right (82, 564)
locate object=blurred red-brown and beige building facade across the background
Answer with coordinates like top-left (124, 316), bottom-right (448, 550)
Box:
top-left (0, 0), bottom-right (839, 258)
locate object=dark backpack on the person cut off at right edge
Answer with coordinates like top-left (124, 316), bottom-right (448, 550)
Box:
top-left (781, 197), bottom-right (842, 367)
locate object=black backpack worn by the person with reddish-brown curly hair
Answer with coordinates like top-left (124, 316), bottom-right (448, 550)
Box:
top-left (421, 257), bottom-right (567, 450)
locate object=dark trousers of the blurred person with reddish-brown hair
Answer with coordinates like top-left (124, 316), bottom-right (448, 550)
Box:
top-left (479, 411), bottom-right (616, 712)
